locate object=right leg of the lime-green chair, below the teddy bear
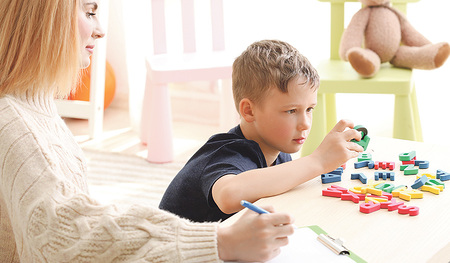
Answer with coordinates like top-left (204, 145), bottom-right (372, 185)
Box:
top-left (394, 95), bottom-right (417, 141)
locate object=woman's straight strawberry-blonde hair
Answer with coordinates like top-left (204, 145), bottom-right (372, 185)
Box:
top-left (0, 0), bottom-right (80, 97)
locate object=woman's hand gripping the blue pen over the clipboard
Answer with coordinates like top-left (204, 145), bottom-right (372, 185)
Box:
top-left (217, 207), bottom-right (294, 261)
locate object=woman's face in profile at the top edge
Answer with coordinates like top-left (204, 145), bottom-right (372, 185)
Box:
top-left (78, 0), bottom-right (105, 68)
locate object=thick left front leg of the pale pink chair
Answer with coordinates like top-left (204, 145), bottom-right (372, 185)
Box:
top-left (142, 81), bottom-right (173, 163)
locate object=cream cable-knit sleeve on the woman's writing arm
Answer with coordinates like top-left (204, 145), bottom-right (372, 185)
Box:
top-left (26, 194), bottom-right (217, 262)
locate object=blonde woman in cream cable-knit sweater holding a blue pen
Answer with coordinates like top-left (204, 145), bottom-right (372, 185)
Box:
top-left (0, 0), bottom-right (293, 262)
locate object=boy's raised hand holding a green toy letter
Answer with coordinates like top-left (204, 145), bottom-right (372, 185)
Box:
top-left (311, 120), bottom-right (364, 173)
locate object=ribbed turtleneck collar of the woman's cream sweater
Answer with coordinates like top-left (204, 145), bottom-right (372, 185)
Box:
top-left (8, 93), bottom-right (58, 118)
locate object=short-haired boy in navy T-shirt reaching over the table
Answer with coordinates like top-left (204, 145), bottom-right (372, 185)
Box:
top-left (159, 40), bottom-right (363, 222)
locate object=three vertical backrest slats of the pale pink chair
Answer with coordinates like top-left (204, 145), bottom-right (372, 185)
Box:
top-left (152, 0), bottom-right (225, 55)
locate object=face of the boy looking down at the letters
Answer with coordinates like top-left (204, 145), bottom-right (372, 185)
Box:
top-left (254, 78), bottom-right (317, 154)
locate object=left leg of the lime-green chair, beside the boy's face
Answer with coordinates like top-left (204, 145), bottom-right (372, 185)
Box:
top-left (301, 94), bottom-right (327, 157)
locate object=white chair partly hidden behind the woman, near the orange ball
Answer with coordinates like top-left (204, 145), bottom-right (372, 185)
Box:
top-left (55, 1), bottom-right (109, 139)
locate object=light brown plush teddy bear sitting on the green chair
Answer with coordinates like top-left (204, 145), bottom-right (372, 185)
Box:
top-left (339, 0), bottom-right (450, 78)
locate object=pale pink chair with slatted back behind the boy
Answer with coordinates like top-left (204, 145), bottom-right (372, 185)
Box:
top-left (141, 0), bottom-right (235, 163)
